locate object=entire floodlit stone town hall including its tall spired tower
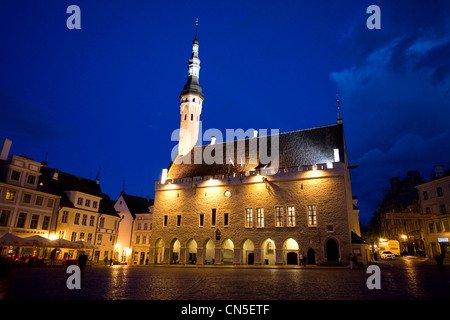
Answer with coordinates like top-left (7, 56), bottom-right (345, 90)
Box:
top-left (150, 30), bottom-right (361, 265)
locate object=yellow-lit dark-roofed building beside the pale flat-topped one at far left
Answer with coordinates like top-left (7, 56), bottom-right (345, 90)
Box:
top-left (40, 165), bottom-right (120, 264)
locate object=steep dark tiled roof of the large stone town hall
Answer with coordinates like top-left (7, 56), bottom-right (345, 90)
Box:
top-left (168, 124), bottom-right (345, 179)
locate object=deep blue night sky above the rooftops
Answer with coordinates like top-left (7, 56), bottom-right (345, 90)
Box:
top-left (0, 0), bottom-right (450, 223)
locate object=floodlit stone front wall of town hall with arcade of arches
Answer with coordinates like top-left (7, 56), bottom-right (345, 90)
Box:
top-left (150, 162), bottom-right (357, 264)
